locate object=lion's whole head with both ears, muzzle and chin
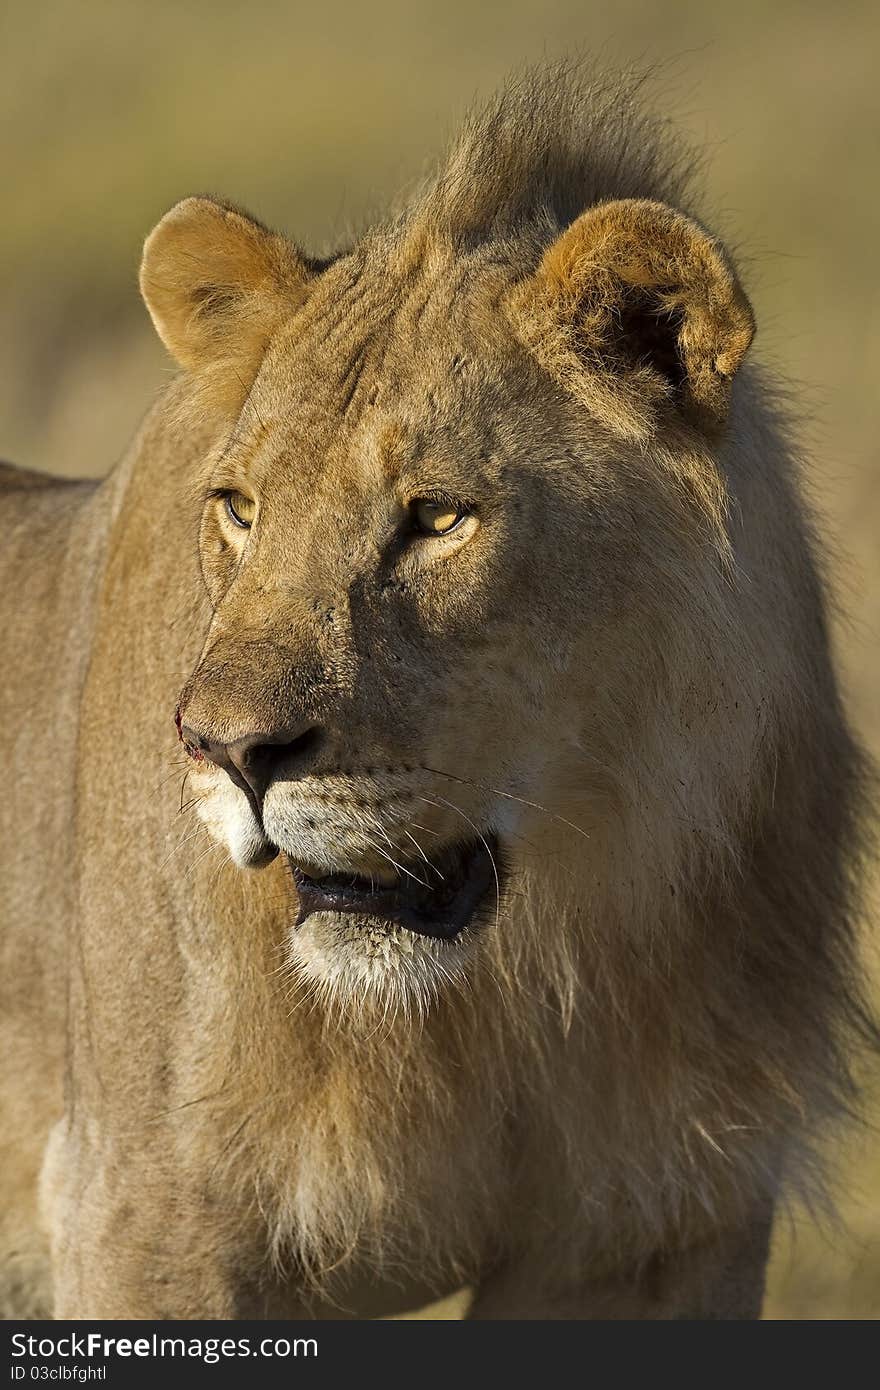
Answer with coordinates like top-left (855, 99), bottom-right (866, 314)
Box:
top-left (142, 81), bottom-right (762, 1028)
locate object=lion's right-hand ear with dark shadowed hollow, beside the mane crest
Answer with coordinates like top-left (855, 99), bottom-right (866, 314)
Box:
top-left (509, 199), bottom-right (755, 438)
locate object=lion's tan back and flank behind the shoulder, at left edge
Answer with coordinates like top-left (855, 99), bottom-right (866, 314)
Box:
top-left (0, 463), bottom-right (104, 1316)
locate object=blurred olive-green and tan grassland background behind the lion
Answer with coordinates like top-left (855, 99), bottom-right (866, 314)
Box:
top-left (0, 0), bottom-right (880, 1318)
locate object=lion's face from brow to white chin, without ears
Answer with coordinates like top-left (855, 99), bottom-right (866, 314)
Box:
top-left (181, 252), bottom-right (596, 1011)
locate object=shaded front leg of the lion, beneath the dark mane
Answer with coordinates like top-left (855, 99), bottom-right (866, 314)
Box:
top-left (468, 1211), bottom-right (772, 1322)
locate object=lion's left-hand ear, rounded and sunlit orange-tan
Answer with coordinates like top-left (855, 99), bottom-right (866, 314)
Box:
top-left (140, 197), bottom-right (309, 389)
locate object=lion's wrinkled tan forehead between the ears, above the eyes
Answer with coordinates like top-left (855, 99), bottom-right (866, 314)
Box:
top-left (250, 253), bottom-right (522, 467)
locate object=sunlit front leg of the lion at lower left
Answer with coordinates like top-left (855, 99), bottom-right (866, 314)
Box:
top-left (42, 1122), bottom-right (282, 1321)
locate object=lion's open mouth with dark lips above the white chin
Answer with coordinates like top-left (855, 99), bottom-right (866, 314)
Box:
top-left (291, 835), bottom-right (499, 941)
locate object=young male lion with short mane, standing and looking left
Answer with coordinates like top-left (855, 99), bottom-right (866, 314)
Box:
top-left (0, 68), bottom-right (873, 1319)
